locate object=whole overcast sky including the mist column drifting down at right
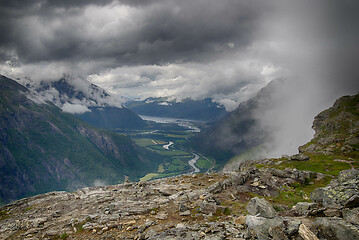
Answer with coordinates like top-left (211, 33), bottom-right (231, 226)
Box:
top-left (0, 0), bottom-right (359, 157)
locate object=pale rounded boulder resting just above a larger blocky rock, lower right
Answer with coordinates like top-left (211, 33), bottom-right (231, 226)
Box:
top-left (246, 197), bottom-right (277, 218)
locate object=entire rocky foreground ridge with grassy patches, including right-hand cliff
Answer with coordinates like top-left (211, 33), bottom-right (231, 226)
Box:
top-left (0, 91), bottom-right (359, 240)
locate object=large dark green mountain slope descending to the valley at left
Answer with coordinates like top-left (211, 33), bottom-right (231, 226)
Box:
top-left (0, 76), bottom-right (161, 202)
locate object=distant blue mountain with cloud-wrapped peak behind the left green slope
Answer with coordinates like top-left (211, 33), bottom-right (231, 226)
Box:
top-left (29, 77), bottom-right (146, 129)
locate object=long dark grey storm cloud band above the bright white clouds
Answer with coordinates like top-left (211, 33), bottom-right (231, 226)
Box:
top-left (0, 0), bottom-right (269, 65)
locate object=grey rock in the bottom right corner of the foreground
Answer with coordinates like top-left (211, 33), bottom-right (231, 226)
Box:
top-left (314, 218), bottom-right (359, 240)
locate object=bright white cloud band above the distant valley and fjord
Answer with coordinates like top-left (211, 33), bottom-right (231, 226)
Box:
top-left (88, 54), bottom-right (268, 110)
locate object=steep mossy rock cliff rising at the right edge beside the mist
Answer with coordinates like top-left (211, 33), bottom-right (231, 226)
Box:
top-left (299, 94), bottom-right (359, 157)
